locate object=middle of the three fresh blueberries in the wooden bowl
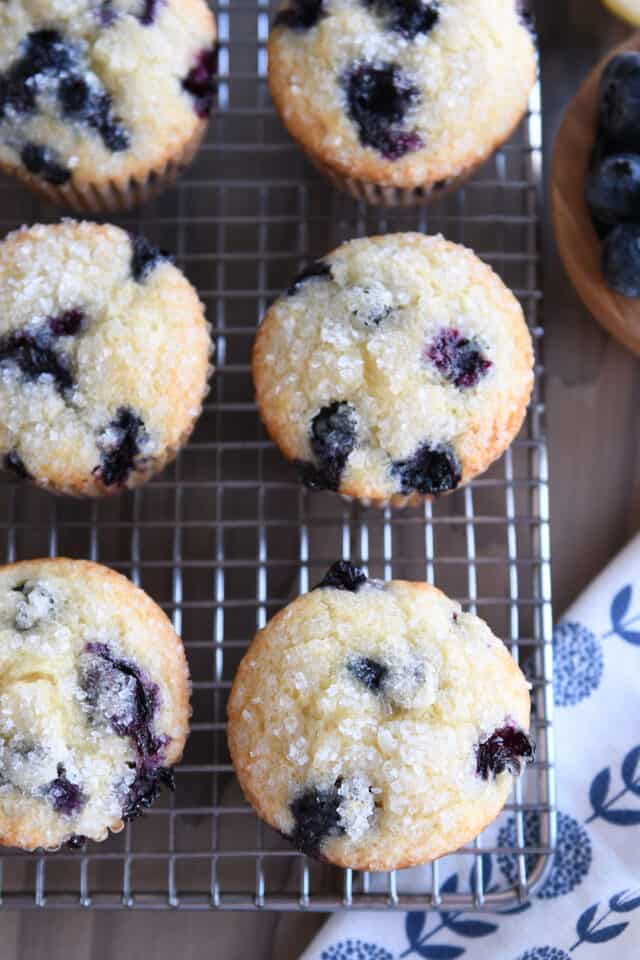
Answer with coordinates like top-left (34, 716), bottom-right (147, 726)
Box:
top-left (586, 153), bottom-right (640, 223)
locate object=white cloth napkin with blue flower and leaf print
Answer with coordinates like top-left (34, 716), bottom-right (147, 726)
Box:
top-left (301, 536), bottom-right (640, 960)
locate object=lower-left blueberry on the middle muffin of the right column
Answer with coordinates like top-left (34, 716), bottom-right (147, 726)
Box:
top-left (300, 401), bottom-right (357, 490)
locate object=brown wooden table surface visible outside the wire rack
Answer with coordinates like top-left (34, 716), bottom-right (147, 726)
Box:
top-left (0, 0), bottom-right (640, 960)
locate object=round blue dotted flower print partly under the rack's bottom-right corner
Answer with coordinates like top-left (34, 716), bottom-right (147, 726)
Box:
top-left (497, 810), bottom-right (592, 900)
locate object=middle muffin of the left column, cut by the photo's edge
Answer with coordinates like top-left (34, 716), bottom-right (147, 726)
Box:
top-left (0, 221), bottom-right (211, 496)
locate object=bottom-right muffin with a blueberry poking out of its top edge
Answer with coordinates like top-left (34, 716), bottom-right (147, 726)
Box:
top-left (228, 561), bottom-right (534, 870)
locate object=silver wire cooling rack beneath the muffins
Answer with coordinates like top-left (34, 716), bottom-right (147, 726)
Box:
top-left (0, 0), bottom-right (555, 911)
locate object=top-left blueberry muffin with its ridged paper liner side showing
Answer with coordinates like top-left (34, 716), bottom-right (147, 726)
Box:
top-left (0, 0), bottom-right (216, 212)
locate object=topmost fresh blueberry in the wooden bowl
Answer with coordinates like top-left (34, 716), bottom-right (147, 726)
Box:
top-left (600, 52), bottom-right (640, 153)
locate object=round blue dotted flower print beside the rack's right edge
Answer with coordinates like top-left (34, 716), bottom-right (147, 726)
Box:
top-left (553, 622), bottom-right (604, 707)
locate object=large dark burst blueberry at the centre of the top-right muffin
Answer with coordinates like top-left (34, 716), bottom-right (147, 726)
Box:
top-left (342, 62), bottom-right (423, 160)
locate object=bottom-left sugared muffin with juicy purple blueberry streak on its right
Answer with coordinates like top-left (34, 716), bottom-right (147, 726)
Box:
top-left (0, 559), bottom-right (190, 850)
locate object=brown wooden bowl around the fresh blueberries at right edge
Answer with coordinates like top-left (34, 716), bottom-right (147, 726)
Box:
top-left (551, 31), bottom-right (640, 356)
